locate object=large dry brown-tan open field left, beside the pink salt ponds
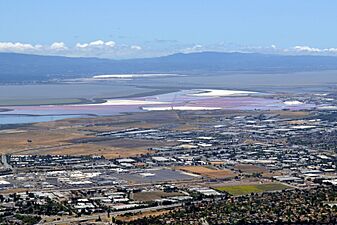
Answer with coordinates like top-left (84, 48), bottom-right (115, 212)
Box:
top-left (0, 113), bottom-right (176, 158)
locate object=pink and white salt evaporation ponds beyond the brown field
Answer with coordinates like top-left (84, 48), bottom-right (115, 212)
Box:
top-left (0, 89), bottom-right (315, 124)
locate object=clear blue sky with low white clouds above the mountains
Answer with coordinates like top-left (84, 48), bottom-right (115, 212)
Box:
top-left (0, 0), bottom-right (337, 58)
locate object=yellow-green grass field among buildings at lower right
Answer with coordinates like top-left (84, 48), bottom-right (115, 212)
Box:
top-left (216, 183), bottom-right (291, 195)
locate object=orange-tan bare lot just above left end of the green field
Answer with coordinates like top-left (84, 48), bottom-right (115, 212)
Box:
top-left (176, 166), bottom-right (234, 178)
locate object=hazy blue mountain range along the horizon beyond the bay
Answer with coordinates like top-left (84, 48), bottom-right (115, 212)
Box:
top-left (0, 52), bottom-right (337, 83)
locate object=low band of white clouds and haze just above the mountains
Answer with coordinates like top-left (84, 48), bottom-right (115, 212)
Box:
top-left (0, 40), bottom-right (337, 59)
